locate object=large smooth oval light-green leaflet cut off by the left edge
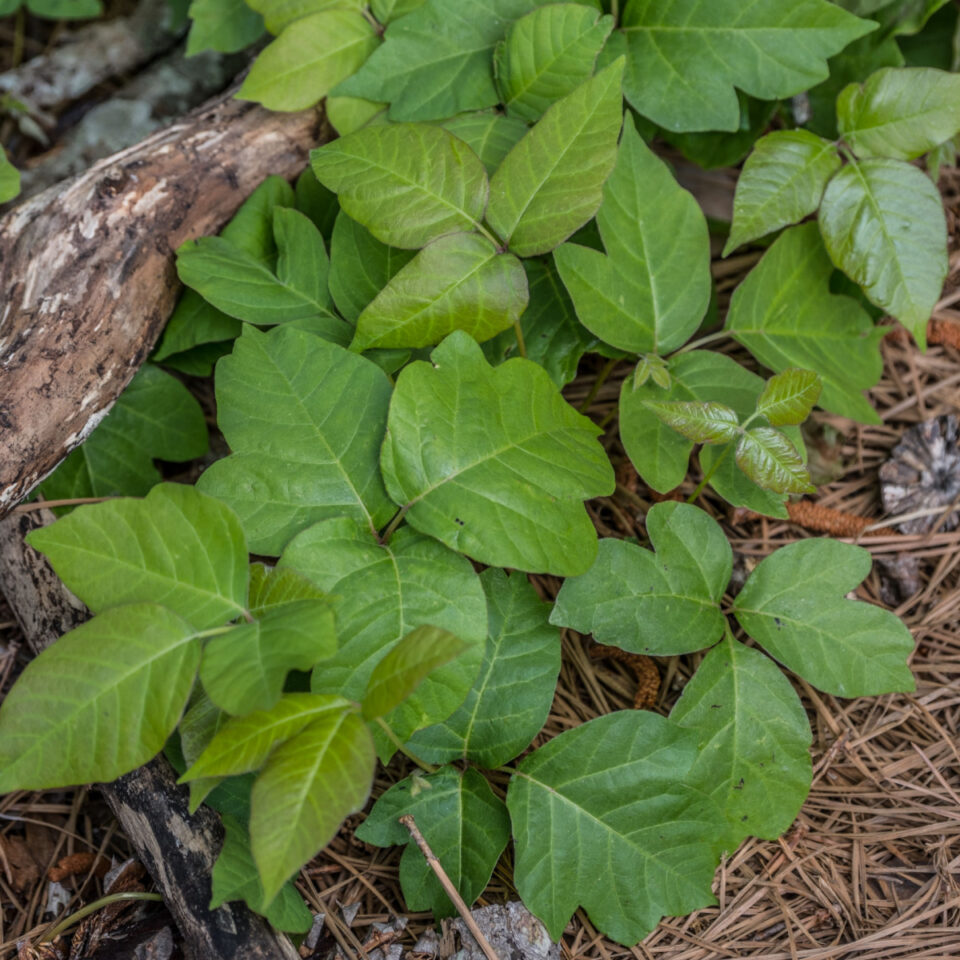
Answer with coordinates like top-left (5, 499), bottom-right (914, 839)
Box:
top-left (0, 604), bottom-right (200, 793)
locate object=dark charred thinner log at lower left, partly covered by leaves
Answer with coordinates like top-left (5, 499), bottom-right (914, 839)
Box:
top-left (0, 510), bottom-right (298, 960)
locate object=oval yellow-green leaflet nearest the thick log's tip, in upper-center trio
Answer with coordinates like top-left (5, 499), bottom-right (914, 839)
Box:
top-left (310, 123), bottom-right (489, 249)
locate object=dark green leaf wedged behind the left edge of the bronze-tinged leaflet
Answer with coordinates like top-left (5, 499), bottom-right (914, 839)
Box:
top-left (330, 210), bottom-right (414, 324)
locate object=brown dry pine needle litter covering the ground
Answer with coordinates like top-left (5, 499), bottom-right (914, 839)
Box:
top-left (0, 178), bottom-right (960, 960)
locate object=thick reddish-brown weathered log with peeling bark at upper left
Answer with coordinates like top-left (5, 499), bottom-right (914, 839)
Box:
top-left (0, 91), bottom-right (321, 516)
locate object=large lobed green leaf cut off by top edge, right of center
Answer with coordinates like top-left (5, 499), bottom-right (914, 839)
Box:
top-left (621, 0), bottom-right (876, 131)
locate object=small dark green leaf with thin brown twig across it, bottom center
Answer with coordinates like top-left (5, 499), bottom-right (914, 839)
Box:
top-left (356, 767), bottom-right (510, 920)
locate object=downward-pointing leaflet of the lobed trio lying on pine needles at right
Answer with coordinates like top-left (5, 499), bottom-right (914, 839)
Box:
top-left (670, 634), bottom-right (812, 847)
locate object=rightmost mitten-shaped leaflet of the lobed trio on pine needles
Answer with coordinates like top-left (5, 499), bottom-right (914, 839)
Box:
top-left (734, 540), bottom-right (914, 697)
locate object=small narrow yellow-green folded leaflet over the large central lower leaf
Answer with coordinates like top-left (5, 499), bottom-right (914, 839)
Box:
top-left (363, 625), bottom-right (467, 722)
